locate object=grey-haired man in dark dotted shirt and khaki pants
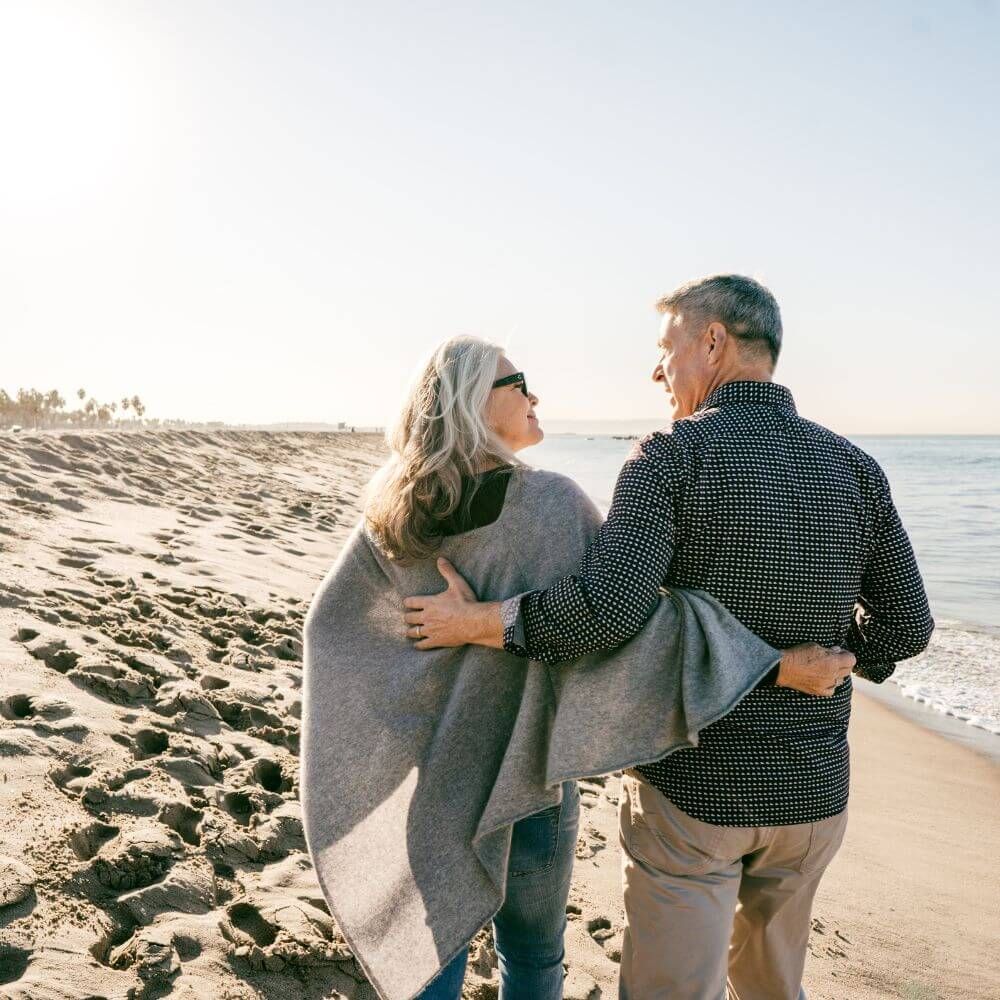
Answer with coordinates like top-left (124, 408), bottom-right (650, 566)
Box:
top-left (406, 275), bottom-right (934, 1000)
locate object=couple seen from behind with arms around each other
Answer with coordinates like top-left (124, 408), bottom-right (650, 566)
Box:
top-left (302, 275), bottom-right (934, 1000)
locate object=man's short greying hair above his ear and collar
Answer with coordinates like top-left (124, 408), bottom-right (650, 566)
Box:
top-left (656, 274), bottom-right (781, 365)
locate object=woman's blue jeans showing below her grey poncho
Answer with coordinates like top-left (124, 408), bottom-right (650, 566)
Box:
top-left (415, 781), bottom-right (580, 1000)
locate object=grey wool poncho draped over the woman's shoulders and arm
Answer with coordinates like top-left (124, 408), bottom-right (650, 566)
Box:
top-left (301, 469), bottom-right (781, 1000)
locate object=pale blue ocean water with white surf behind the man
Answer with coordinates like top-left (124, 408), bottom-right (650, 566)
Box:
top-left (522, 434), bottom-right (1000, 736)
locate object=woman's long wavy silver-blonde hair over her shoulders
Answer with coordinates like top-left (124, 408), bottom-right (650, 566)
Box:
top-left (365, 337), bottom-right (521, 559)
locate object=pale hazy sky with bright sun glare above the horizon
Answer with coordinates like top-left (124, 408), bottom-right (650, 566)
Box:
top-left (0, 0), bottom-right (1000, 434)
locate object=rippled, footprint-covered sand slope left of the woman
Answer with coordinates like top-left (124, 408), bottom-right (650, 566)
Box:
top-left (0, 432), bottom-right (381, 1000)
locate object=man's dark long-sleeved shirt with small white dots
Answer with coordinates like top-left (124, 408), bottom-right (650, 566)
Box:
top-left (502, 382), bottom-right (934, 826)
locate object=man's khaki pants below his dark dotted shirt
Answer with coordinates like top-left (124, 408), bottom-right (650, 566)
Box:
top-left (618, 770), bottom-right (847, 1000)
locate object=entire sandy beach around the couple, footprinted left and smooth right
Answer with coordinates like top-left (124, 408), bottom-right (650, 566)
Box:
top-left (0, 431), bottom-right (1000, 1000)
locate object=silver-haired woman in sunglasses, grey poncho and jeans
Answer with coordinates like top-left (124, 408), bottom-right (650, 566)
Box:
top-left (302, 337), bottom-right (848, 1000)
